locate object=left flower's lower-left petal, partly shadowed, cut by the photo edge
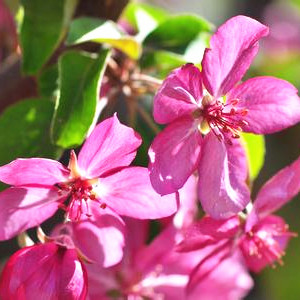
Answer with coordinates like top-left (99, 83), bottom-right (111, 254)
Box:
top-left (0, 187), bottom-right (64, 240)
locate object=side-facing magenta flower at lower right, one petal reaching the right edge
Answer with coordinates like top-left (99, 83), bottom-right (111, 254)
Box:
top-left (178, 158), bottom-right (300, 288)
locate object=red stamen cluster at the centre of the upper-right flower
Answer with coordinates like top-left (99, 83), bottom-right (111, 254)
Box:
top-left (193, 95), bottom-right (248, 144)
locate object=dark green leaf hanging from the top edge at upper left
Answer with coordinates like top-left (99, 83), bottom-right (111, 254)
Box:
top-left (20, 0), bottom-right (77, 74)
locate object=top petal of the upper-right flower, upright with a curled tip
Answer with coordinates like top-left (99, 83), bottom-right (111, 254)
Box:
top-left (202, 16), bottom-right (268, 97)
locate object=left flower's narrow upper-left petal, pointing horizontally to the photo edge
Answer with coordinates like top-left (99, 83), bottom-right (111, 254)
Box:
top-left (0, 158), bottom-right (70, 186)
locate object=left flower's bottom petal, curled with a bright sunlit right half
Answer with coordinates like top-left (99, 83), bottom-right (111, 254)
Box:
top-left (72, 202), bottom-right (125, 268)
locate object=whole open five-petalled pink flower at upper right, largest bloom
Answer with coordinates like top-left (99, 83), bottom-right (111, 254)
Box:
top-left (149, 16), bottom-right (300, 218)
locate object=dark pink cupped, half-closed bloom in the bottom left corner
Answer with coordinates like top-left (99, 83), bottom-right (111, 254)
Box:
top-left (0, 242), bottom-right (87, 300)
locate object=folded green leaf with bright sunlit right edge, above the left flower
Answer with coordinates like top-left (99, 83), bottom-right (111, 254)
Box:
top-left (52, 50), bottom-right (109, 148)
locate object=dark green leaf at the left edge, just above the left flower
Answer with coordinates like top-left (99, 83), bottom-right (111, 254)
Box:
top-left (0, 99), bottom-right (61, 165)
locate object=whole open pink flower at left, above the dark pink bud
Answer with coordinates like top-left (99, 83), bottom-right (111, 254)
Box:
top-left (0, 116), bottom-right (177, 266)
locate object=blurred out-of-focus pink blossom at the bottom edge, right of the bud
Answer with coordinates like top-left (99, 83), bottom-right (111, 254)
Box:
top-left (87, 220), bottom-right (253, 300)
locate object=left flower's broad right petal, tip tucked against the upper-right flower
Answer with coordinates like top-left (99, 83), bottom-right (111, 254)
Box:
top-left (97, 167), bottom-right (178, 219)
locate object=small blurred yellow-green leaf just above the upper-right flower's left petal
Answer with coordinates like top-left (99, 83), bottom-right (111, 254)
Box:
top-left (140, 50), bottom-right (186, 79)
